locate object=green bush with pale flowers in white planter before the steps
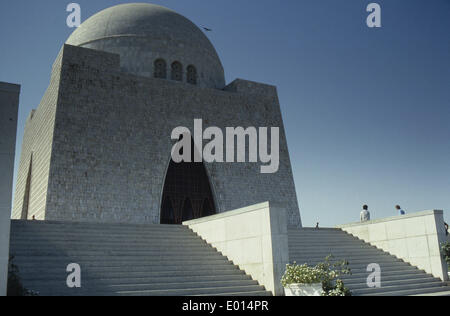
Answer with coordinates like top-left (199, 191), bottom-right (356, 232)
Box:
top-left (281, 255), bottom-right (351, 296)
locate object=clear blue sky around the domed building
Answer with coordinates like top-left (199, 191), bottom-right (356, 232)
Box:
top-left (0, 0), bottom-right (450, 226)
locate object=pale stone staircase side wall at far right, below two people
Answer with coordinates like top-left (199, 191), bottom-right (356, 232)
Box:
top-left (338, 210), bottom-right (448, 281)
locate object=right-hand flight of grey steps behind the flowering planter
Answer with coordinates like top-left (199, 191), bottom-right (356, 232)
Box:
top-left (288, 228), bottom-right (450, 296)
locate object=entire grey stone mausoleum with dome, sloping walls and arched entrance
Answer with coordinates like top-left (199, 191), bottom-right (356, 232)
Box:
top-left (13, 4), bottom-right (301, 227)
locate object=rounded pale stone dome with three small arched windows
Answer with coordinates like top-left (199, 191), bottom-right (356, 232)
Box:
top-left (66, 3), bottom-right (225, 89)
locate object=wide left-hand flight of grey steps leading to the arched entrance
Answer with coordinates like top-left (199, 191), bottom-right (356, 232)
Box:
top-left (10, 221), bottom-right (270, 296)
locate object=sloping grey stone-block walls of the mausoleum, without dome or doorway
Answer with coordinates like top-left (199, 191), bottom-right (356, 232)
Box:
top-left (14, 45), bottom-right (301, 226)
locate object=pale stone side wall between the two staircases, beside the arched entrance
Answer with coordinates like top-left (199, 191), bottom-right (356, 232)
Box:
top-left (183, 202), bottom-right (289, 296)
